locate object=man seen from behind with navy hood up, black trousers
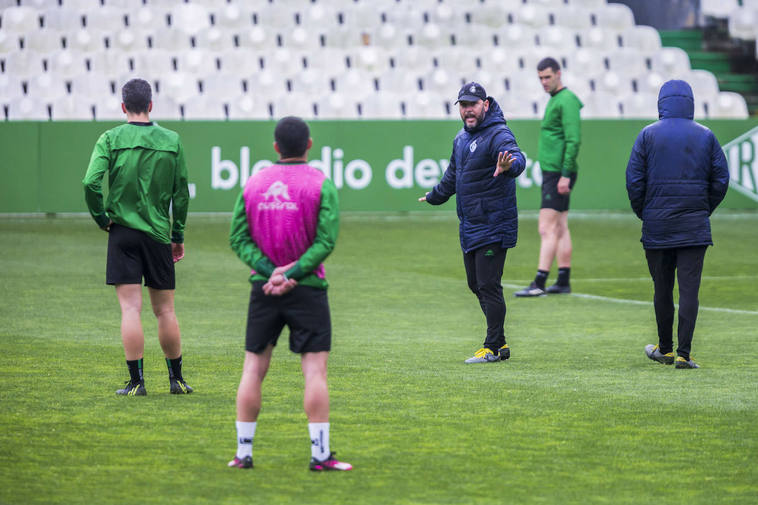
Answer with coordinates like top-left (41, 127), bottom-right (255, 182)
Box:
top-left (626, 80), bottom-right (729, 368)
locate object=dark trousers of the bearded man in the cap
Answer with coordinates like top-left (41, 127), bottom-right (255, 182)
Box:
top-left (463, 244), bottom-right (508, 353)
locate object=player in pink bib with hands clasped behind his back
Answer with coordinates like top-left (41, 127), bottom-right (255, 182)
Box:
top-left (229, 117), bottom-right (353, 471)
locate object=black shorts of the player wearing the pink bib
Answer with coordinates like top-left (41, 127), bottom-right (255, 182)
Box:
top-left (245, 281), bottom-right (332, 354)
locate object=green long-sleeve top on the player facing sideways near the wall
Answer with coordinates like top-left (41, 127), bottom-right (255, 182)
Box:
top-left (538, 88), bottom-right (583, 177)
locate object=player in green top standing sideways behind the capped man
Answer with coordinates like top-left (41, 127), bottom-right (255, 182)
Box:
top-left (516, 58), bottom-right (582, 297)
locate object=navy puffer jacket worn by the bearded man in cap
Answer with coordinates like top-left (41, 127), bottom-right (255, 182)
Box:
top-left (426, 97), bottom-right (526, 252)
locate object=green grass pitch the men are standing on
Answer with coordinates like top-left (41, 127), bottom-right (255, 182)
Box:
top-left (0, 212), bottom-right (758, 505)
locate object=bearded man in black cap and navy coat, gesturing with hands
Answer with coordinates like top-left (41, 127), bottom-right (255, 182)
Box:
top-left (419, 82), bottom-right (526, 363)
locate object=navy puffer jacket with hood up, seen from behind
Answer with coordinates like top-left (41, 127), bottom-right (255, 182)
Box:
top-left (626, 80), bottom-right (729, 249)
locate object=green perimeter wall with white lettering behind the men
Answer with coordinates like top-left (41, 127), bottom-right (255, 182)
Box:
top-left (0, 119), bottom-right (758, 213)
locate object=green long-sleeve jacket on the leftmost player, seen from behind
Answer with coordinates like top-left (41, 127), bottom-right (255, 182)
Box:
top-left (82, 123), bottom-right (189, 244)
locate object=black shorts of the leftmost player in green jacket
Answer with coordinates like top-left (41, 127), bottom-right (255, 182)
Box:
top-left (105, 224), bottom-right (176, 289)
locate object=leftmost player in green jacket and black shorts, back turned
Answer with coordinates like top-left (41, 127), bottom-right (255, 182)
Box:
top-left (82, 79), bottom-right (192, 396)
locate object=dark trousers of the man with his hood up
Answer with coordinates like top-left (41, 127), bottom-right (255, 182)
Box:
top-left (645, 246), bottom-right (707, 359)
